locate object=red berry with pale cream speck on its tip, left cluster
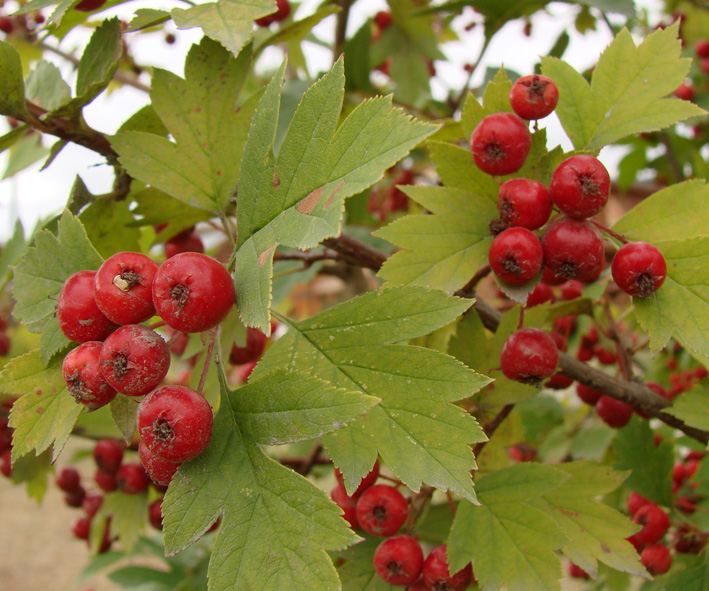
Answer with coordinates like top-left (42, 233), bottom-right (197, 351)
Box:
top-left (94, 252), bottom-right (158, 324)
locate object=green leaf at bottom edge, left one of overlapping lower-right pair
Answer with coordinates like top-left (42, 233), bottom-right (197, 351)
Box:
top-left (448, 464), bottom-right (569, 591)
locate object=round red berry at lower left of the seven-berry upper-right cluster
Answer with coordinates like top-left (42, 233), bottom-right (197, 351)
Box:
top-left (488, 228), bottom-right (544, 285)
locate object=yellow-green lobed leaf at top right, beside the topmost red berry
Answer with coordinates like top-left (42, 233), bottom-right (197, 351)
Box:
top-left (542, 23), bottom-right (705, 151)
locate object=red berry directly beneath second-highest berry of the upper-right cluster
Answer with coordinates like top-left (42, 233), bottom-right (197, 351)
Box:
top-left (497, 179), bottom-right (552, 230)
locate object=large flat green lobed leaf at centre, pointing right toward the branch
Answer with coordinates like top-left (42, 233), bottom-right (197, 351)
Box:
top-left (253, 286), bottom-right (489, 502)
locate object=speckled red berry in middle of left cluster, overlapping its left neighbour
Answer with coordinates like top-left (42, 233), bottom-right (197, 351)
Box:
top-left (100, 324), bottom-right (170, 396)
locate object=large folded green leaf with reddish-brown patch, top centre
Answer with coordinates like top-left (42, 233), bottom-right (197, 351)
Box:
top-left (235, 58), bottom-right (436, 332)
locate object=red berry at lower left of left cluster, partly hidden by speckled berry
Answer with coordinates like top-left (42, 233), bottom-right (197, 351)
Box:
top-left (62, 341), bottom-right (116, 410)
